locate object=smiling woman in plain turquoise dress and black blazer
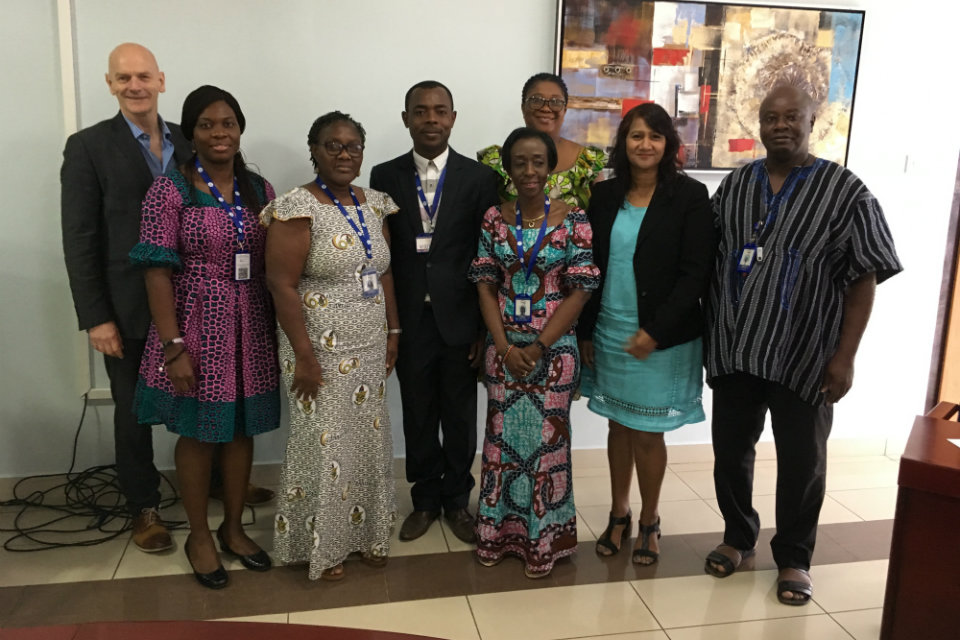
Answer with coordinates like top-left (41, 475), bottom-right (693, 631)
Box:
top-left (578, 103), bottom-right (716, 565)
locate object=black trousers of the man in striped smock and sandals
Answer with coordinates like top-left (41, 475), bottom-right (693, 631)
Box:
top-left (712, 373), bottom-right (833, 569)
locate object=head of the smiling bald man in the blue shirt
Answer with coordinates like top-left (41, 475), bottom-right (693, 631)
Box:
top-left (106, 42), bottom-right (166, 126)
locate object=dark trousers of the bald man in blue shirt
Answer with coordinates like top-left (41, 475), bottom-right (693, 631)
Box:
top-left (103, 339), bottom-right (160, 515)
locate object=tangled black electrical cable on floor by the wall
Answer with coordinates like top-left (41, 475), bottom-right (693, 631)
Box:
top-left (0, 393), bottom-right (256, 552)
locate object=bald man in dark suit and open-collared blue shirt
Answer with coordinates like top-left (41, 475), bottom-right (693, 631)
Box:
top-left (60, 43), bottom-right (190, 552)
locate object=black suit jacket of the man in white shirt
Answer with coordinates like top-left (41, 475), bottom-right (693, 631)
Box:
top-left (370, 149), bottom-right (500, 345)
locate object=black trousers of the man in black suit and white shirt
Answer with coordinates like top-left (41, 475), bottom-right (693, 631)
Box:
top-left (397, 304), bottom-right (477, 511)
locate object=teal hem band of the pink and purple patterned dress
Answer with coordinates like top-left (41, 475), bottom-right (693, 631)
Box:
top-left (135, 377), bottom-right (280, 442)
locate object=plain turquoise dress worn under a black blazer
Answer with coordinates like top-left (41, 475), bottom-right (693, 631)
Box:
top-left (581, 203), bottom-right (706, 432)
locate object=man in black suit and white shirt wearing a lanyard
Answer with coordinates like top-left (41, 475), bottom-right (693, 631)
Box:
top-left (370, 80), bottom-right (499, 542)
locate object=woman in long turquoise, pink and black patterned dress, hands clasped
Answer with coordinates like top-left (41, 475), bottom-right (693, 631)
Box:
top-left (470, 128), bottom-right (600, 578)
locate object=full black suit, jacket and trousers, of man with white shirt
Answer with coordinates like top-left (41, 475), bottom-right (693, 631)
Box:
top-left (370, 149), bottom-right (499, 511)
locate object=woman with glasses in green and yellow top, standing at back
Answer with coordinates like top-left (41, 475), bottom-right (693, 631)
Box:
top-left (477, 73), bottom-right (607, 209)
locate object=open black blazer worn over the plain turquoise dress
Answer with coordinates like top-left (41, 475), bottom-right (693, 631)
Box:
top-left (577, 175), bottom-right (717, 349)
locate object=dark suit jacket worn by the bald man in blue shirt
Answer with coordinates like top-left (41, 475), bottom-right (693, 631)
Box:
top-left (60, 112), bottom-right (191, 339)
